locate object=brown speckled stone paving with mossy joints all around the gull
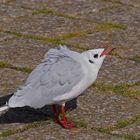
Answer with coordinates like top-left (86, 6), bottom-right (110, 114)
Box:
top-left (0, 0), bottom-right (140, 140)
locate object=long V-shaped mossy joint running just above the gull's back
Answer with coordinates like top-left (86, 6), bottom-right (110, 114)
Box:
top-left (0, 23), bottom-right (127, 44)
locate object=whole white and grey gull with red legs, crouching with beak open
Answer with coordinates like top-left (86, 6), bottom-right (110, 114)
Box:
top-left (0, 45), bottom-right (114, 129)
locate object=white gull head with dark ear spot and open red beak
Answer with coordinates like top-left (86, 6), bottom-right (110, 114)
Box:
top-left (82, 47), bottom-right (115, 71)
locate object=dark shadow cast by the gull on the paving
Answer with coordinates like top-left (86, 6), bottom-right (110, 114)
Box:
top-left (0, 95), bottom-right (77, 124)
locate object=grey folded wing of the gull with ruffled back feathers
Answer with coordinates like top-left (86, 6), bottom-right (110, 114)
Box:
top-left (8, 49), bottom-right (84, 108)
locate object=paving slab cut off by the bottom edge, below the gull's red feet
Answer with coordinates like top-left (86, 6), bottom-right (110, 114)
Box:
top-left (3, 124), bottom-right (124, 140)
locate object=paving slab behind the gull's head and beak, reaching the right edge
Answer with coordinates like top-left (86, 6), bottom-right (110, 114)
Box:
top-left (65, 27), bottom-right (140, 58)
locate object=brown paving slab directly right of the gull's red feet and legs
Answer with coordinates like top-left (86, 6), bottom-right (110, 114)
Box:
top-left (72, 87), bottom-right (140, 128)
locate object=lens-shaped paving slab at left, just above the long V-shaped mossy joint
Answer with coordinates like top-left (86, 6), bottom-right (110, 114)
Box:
top-left (0, 14), bottom-right (95, 38)
